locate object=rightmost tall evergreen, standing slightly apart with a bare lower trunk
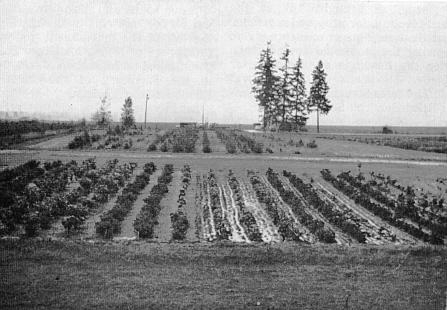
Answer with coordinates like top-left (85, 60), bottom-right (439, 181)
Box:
top-left (308, 60), bottom-right (332, 133)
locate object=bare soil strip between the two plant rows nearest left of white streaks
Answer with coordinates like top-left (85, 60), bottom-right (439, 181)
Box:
top-left (154, 170), bottom-right (182, 242)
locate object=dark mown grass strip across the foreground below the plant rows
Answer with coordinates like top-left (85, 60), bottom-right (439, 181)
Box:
top-left (0, 240), bottom-right (447, 309)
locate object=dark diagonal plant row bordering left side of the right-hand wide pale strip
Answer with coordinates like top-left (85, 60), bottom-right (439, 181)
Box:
top-left (283, 170), bottom-right (366, 243)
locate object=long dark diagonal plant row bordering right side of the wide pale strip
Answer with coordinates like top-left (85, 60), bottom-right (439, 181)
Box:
top-left (321, 169), bottom-right (444, 244)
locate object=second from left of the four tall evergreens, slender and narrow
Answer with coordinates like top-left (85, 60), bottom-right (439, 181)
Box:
top-left (276, 48), bottom-right (294, 128)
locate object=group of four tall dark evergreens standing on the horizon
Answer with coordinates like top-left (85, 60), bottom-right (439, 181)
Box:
top-left (252, 42), bottom-right (332, 132)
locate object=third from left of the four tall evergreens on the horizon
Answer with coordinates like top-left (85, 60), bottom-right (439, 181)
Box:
top-left (290, 57), bottom-right (309, 130)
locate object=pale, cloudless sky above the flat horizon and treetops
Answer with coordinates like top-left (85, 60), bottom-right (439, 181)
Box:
top-left (0, 0), bottom-right (447, 126)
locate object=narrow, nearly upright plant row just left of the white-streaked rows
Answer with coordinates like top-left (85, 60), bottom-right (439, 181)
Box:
top-left (171, 165), bottom-right (191, 240)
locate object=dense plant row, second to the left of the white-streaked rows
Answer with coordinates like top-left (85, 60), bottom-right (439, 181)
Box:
top-left (134, 164), bottom-right (174, 238)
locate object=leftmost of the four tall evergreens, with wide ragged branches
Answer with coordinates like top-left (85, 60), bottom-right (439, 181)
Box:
top-left (252, 42), bottom-right (279, 128)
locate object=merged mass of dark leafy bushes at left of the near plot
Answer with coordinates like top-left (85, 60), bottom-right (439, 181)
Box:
top-left (1, 159), bottom-right (133, 236)
